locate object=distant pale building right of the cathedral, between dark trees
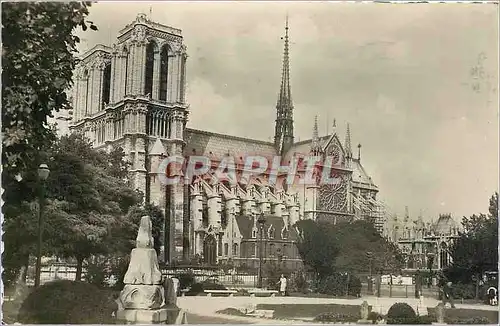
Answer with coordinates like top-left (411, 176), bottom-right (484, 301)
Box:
top-left (385, 210), bottom-right (460, 271)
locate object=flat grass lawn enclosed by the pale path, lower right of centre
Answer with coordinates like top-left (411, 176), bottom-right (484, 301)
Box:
top-left (257, 304), bottom-right (371, 319)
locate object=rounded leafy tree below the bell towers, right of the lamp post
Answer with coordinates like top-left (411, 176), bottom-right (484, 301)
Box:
top-left (46, 134), bottom-right (142, 280)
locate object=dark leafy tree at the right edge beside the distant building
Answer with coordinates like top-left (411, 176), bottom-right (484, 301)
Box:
top-left (444, 193), bottom-right (498, 284)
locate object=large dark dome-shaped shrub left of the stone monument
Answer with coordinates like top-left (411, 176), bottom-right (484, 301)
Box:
top-left (19, 280), bottom-right (118, 324)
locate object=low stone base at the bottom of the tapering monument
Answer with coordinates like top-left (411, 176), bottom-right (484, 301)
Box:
top-left (116, 307), bottom-right (187, 324)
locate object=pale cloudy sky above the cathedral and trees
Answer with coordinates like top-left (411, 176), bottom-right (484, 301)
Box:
top-left (79, 2), bottom-right (499, 219)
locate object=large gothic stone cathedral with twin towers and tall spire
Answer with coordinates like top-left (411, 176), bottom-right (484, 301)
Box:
top-left (69, 14), bottom-right (384, 268)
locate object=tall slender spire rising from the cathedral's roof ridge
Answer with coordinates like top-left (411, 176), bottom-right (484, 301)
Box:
top-left (274, 15), bottom-right (293, 155)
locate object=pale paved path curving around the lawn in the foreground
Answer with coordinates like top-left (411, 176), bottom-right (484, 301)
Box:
top-left (177, 296), bottom-right (498, 324)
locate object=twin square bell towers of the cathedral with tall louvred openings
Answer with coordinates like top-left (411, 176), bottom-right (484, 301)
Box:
top-left (70, 14), bottom-right (188, 259)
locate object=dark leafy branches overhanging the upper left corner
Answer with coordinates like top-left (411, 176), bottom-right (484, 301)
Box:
top-left (2, 2), bottom-right (97, 176)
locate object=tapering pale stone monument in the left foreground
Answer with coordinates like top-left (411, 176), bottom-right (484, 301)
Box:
top-left (116, 216), bottom-right (187, 324)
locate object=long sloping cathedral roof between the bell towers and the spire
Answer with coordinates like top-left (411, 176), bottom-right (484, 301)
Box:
top-left (184, 128), bottom-right (276, 162)
